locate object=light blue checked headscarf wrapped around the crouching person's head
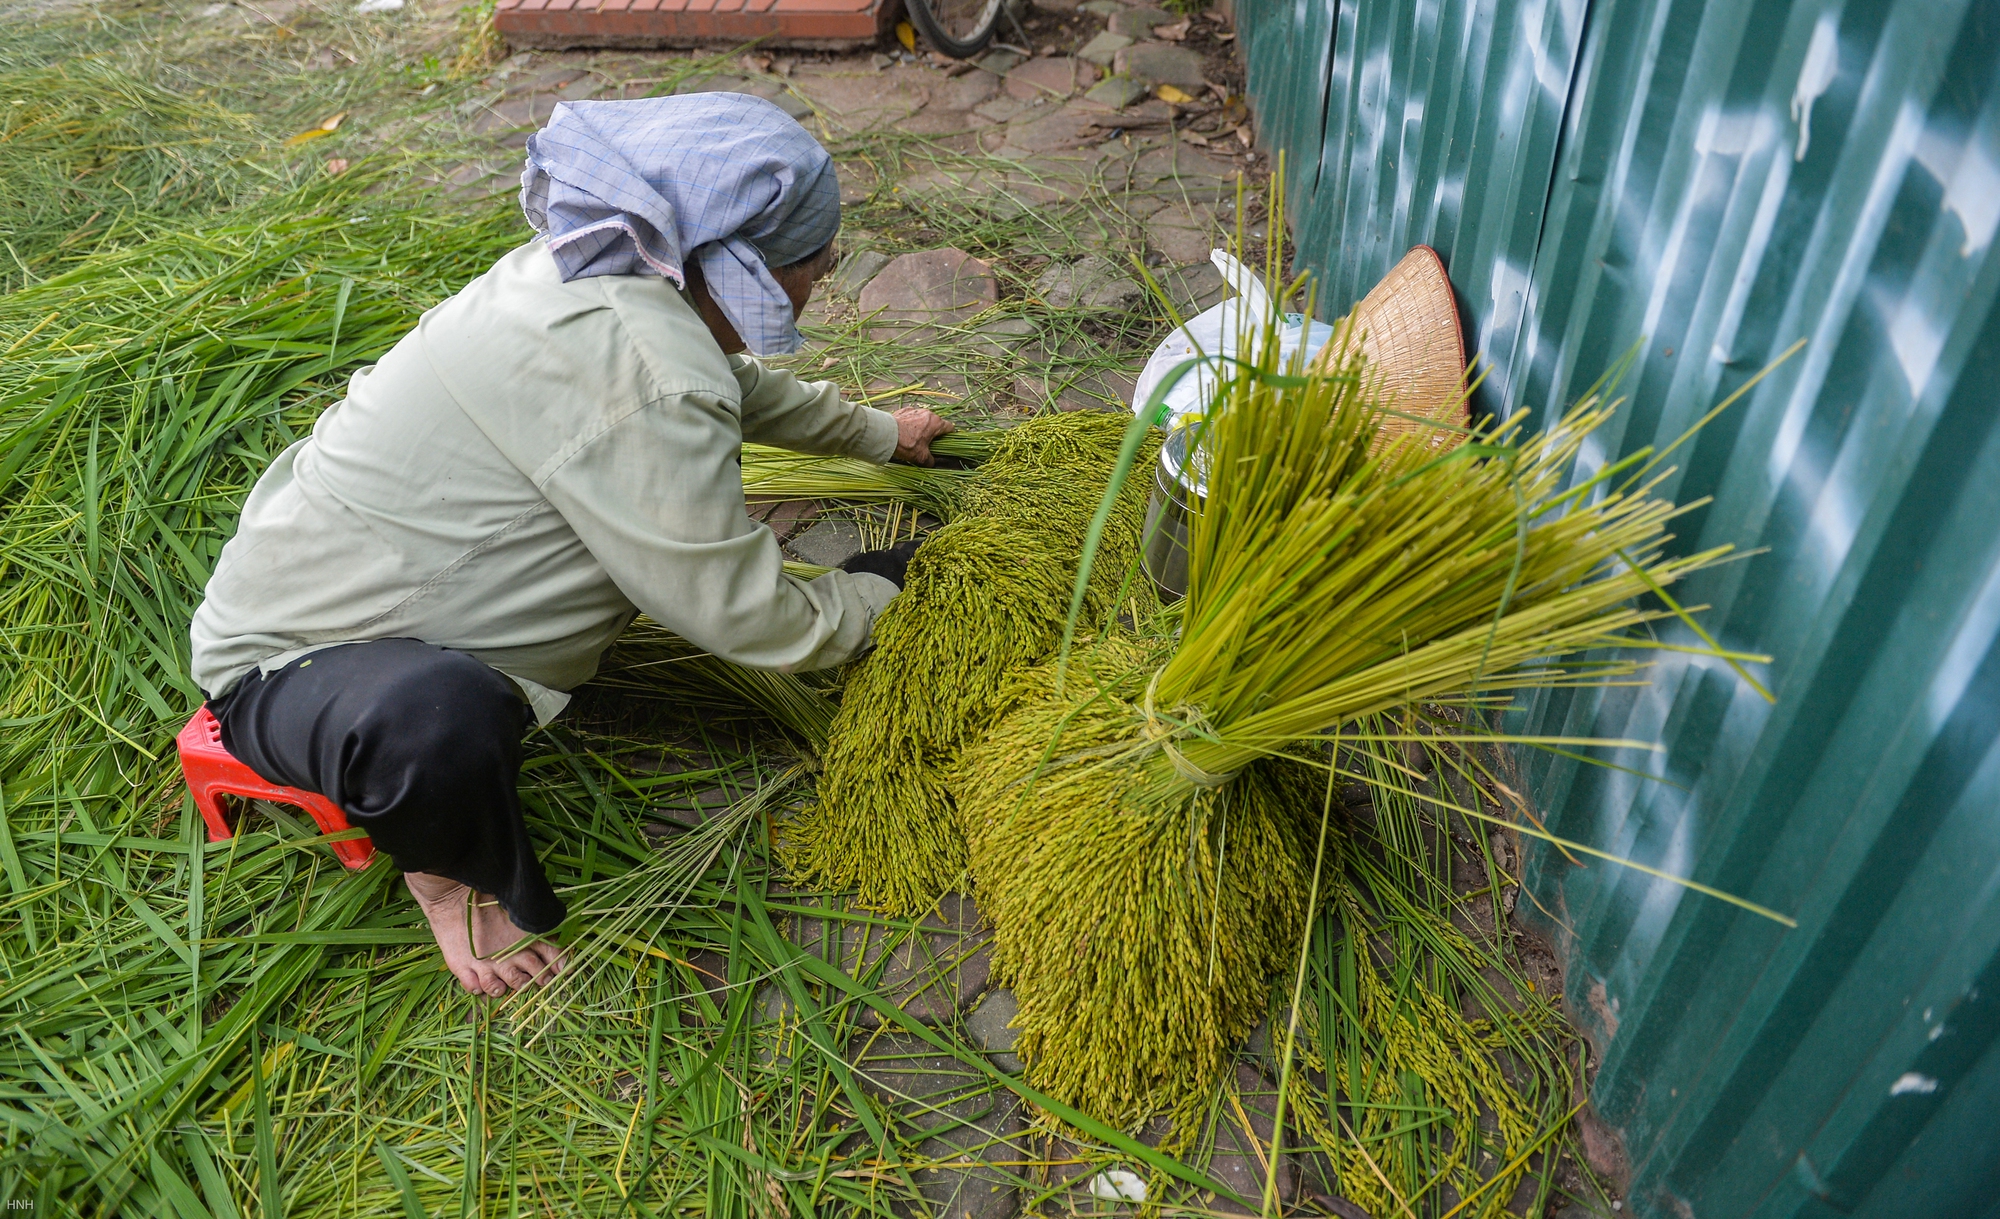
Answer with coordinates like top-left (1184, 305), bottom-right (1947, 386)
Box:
top-left (520, 94), bottom-right (840, 356)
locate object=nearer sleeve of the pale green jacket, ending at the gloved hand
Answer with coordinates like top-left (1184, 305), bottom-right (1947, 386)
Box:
top-left (542, 383), bottom-right (896, 671)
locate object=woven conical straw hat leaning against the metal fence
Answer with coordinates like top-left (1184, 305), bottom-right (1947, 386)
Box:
top-left (1318, 246), bottom-right (1468, 452)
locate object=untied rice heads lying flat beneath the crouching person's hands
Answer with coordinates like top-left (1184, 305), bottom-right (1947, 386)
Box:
top-left (786, 412), bottom-right (1150, 913)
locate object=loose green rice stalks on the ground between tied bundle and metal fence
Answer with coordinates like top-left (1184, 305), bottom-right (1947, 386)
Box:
top-left (1290, 725), bottom-right (1570, 1215)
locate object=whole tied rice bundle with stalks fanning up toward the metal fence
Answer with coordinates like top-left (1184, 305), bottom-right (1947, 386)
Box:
top-left (952, 323), bottom-right (1752, 1125)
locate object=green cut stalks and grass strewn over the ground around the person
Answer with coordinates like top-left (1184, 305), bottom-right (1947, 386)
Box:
top-left (0, 4), bottom-right (1624, 1219)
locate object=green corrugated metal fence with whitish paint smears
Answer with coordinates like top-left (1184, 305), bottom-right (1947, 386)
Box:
top-left (1238, 0), bottom-right (2000, 1219)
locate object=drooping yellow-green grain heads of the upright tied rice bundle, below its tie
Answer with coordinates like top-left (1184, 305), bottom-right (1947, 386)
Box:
top-left (952, 637), bottom-right (1318, 1141)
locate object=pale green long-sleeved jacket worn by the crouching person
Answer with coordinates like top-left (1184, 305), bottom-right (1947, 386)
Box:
top-left (190, 242), bottom-right (896, 723)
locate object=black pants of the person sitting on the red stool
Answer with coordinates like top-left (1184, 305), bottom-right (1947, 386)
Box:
top-left (208, 639), bottom-right (566, 931)
